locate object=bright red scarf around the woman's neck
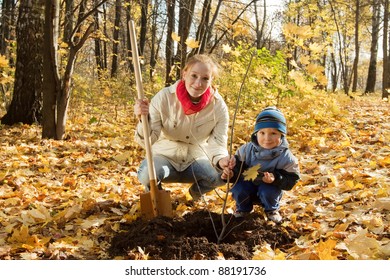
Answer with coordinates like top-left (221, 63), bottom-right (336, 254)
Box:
top-left (176, 81), bottom-right (212, 115)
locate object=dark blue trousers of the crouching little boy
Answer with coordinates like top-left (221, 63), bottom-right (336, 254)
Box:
top-left (231, 180), bottom-right (283, 212)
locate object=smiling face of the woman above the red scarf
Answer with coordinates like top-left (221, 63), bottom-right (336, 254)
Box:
top-left (183, 62), bottom-right (212, 101)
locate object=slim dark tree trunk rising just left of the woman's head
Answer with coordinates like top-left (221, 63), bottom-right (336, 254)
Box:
top-left (165, 0), bottom-right (175, 86)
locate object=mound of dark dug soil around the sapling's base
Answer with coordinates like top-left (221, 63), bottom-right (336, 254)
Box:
top-left (110, 211), bottom-right (299, 260)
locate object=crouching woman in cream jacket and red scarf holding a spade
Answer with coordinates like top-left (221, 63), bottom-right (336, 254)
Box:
top-left (134, 55), bottom-right (229, 200)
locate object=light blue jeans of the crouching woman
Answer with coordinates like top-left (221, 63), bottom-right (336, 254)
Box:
top-left (138, 156), bottom-right (225, 196)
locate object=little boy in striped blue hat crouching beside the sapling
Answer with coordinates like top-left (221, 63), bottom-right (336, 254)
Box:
top-left (221, 107), bottom-right (300, 223)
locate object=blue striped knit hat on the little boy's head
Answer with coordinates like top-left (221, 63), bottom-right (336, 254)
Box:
top-left (252, 106), bottom-right (287, 139)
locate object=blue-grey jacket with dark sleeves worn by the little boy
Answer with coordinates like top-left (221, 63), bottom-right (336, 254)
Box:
top-left (230, 137), bottom-right (300, 190)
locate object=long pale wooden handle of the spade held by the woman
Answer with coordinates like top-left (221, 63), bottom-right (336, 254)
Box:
top-left (129, 20), bottom-right (158, 216)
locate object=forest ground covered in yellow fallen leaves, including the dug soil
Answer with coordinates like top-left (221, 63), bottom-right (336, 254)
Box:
top-left (0, 96), bottom-right (390, 259)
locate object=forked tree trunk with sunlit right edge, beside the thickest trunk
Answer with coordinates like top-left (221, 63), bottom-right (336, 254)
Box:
top-left (42, 0), bottom-right (106, 140)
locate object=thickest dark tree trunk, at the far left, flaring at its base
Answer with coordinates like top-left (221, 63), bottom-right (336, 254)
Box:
top-left (1, 0), bottom-right (44, 125)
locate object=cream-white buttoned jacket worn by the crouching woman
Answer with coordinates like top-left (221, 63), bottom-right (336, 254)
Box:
top-left (135, 82), bottom-right (229, 171)
